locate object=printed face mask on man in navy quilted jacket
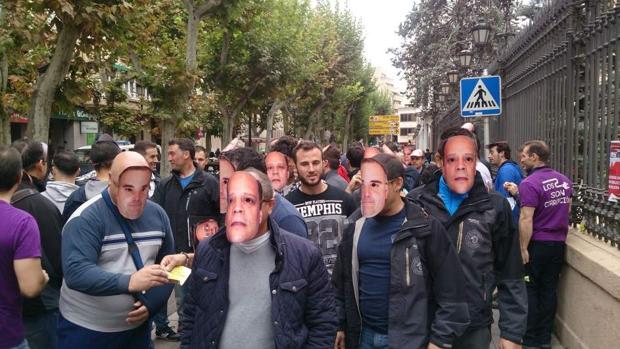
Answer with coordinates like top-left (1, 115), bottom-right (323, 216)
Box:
top-left (226, 172), bottom-right (262, 243)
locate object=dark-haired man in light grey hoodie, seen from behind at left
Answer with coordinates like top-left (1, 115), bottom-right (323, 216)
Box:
top-left (41, 151), bottom-right (80, 212)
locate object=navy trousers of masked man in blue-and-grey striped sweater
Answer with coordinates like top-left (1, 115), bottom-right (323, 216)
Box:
top-left (58, 314), bottom-right (153, 349)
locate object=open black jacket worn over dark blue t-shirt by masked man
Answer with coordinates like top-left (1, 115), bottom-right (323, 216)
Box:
top-left (332, 202), bottom-right (468, 349)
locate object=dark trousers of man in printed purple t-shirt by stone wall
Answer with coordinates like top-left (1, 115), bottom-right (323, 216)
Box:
top-left (523, 241), bottom-right (566, 347)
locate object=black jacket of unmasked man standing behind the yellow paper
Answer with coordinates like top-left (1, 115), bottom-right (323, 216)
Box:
top-left (151, 164), bottom-right (220, 252)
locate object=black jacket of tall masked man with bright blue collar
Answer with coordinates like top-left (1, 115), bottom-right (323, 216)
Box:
top-left (407, 173), bottom-right (527, 343)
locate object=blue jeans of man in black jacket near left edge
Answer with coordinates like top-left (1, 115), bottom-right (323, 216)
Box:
top-left (23, 310), bottom-right (58, 349)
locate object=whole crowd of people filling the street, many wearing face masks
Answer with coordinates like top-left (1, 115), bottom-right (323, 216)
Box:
top-left (0, 124), bottom-right (572, 349)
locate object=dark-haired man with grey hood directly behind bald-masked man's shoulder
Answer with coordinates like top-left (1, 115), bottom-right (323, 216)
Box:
top-left (62, 140), bottom-right (121, 222)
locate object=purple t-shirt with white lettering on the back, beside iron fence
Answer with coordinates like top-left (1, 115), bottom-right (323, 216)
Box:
top-left (519, 167), bottom-right (573, 241)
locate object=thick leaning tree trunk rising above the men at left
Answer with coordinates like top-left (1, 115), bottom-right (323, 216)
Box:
top-left (27, 18), bottom-right (81, 142)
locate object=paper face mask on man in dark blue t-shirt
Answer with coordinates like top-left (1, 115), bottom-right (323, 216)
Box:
top-left (360, 161), bottom-right (388, 218)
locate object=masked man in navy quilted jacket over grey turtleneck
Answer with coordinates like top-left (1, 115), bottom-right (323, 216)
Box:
top-left (181, 171), bottom-right (337, 349)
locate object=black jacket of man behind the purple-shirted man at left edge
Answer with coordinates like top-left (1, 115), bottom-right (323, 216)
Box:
top-left (11, 174), bottom-right (63, 317)
